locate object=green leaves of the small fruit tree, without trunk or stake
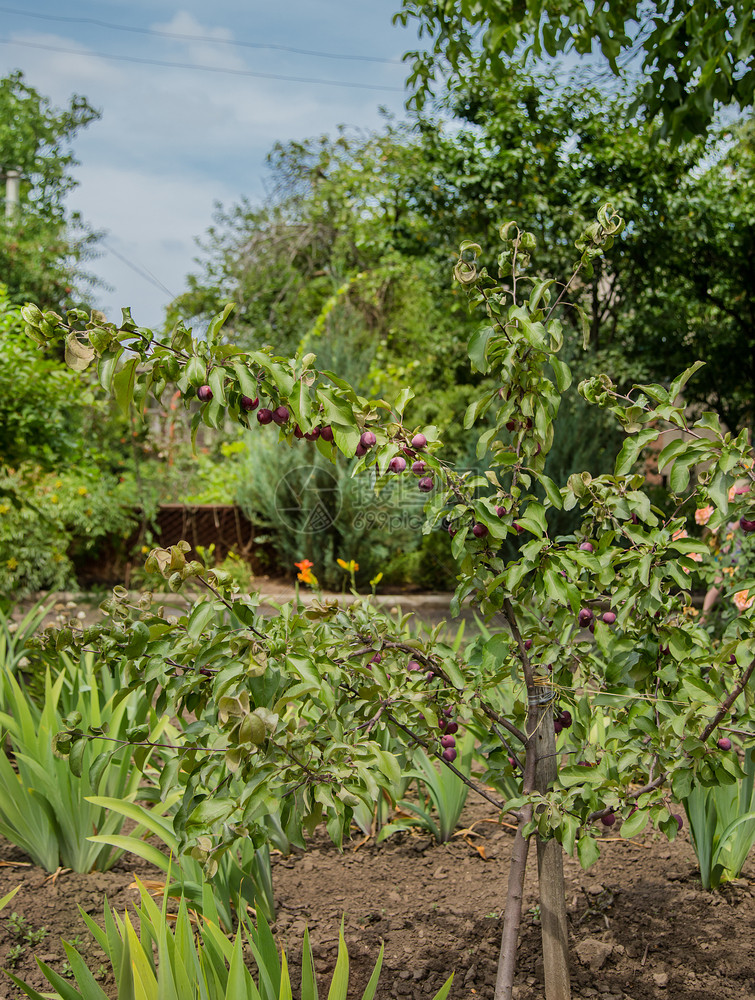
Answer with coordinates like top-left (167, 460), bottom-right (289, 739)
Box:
top-left (26, 206), bottom-right (752, 863)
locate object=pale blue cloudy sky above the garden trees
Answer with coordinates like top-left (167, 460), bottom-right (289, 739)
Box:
top-left (0, 0), bottom-right (416, 325)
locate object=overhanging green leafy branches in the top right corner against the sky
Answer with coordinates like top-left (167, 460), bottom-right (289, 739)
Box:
top-left (394, 0), bottom-right (755, 139)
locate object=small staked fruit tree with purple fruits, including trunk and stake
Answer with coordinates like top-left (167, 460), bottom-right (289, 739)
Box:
top-left (24, 206), bottom-right (755, 1000)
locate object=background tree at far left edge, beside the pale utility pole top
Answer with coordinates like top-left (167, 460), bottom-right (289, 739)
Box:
top-left (0, 72), bottom-right (99, 309)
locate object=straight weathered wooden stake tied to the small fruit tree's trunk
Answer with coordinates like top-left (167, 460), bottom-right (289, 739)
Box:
top-left (532, 701), bottom-right (571, 1000)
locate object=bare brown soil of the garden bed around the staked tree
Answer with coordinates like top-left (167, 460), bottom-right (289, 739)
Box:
top-left (0, 802), bottom-right (755, 1000)
